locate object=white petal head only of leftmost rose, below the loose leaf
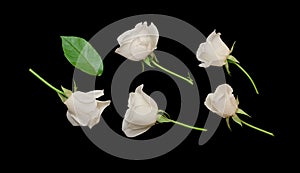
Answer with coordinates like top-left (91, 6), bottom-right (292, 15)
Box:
top-left (64, 90), bottom-right (110, 128)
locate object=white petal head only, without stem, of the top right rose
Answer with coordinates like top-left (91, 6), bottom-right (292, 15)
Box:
top-left (196, 31), bottom-right (230, 68)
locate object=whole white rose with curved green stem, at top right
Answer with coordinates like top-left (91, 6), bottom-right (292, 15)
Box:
top-left (196, 30), bottom-right (258, 94)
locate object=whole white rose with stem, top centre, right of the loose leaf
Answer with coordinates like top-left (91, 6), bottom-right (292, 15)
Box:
top-left (115, 22), bottom-right (193, 85)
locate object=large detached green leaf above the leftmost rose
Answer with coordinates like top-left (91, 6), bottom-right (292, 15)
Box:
top-left (61, 36), bottom-right (103, 76)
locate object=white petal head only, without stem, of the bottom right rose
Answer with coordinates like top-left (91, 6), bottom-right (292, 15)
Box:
top-left (204, 84), bottom-right (238, 118)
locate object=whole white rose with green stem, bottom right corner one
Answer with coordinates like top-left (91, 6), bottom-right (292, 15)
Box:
top-left (204, 84), bottom-right (274, 136)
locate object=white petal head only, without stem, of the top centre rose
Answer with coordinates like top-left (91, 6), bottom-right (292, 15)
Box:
top-left (115, 22), bottom-right (159, 61)
